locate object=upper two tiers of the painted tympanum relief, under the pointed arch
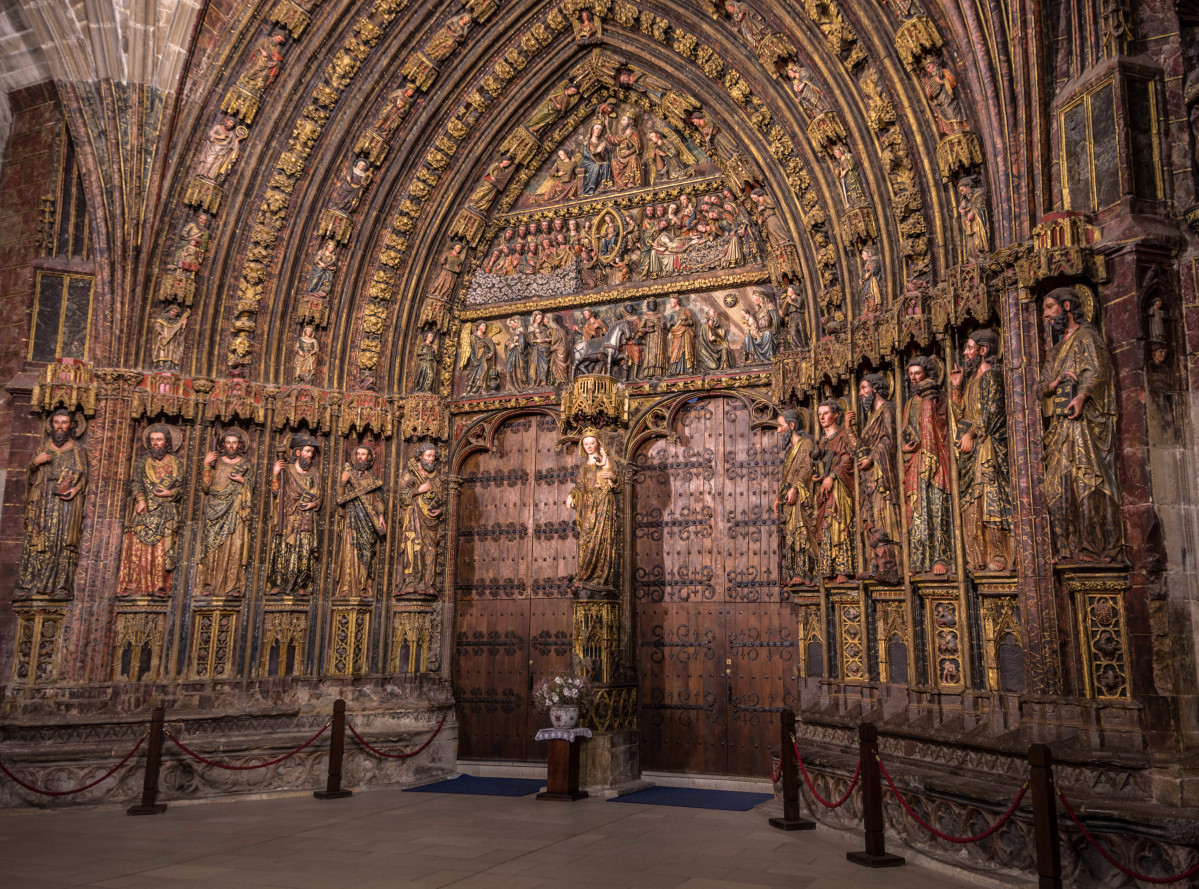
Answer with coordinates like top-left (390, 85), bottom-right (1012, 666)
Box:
top-left (465, 106), bottom-right (763, 306)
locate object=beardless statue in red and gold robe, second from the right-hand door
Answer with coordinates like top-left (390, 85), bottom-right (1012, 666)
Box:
top-left (812, 400), bottom-right (857, 583)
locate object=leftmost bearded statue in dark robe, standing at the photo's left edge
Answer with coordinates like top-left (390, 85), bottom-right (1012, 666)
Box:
top-left (13, 408), bottom-right (88, 600)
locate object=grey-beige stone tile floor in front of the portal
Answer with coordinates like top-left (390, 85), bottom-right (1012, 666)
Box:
top-left (0, 789), bottom-right (969, 889)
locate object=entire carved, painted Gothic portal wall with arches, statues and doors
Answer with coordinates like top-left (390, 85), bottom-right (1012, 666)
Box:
top-left (0, 0), bottom-right (1199, 885)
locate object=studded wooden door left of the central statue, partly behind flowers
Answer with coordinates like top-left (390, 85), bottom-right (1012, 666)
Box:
top-left (453, 415), bottom-right (577, 759)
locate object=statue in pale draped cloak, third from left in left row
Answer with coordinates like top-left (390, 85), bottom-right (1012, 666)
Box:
top-left (198, 427), bottom-right (254, 597)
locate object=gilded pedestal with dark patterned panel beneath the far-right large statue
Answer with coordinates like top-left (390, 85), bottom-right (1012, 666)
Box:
top-left (1062, 566), bottom-right (1132, 701)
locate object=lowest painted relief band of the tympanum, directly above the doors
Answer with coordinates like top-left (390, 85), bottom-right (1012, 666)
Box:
top-left (454, 284), bottom-right (788, 397)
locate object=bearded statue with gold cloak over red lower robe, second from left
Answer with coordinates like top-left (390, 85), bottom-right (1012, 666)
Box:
top-left (116, 424), bottom-right (183, 596)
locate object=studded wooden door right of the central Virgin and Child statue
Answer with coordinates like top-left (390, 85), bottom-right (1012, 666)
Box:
top-left (633, 397), bottom-right (797, 776)
